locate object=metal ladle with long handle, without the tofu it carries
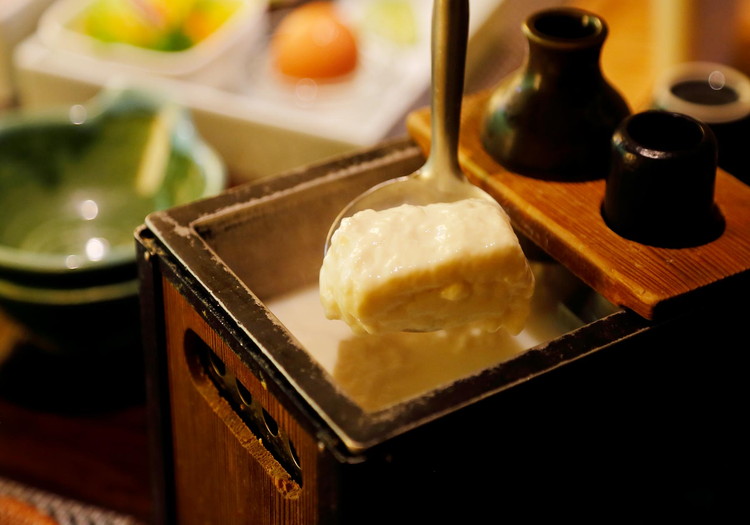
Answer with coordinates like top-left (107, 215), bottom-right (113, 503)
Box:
top-left (325, 0), bottom-right (496, 251)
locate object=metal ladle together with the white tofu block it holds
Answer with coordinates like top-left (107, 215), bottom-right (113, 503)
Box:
top-left (320, 0), bottom-right (534, 333)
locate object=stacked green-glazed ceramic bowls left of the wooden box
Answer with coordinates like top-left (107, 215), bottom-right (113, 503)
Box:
top-left (0, 90), bottom-right (226, 349)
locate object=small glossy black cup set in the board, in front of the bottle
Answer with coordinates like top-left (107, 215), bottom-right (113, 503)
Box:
top-left (602, 110), bottom-right (724, 248)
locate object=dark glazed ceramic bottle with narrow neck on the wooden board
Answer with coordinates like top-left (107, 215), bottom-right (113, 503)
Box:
top-left (481, 8), bottom-right (630, 180)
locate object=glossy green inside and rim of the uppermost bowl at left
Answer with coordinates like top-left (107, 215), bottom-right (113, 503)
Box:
top-left (0, 87), bottom-right (224, 273)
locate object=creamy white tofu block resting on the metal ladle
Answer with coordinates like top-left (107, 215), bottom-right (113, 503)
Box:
top-left (319, 199), bottom-right (534, 334)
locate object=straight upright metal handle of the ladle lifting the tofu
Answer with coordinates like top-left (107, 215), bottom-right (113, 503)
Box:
top-left (428, 0), bottom-right (469, 178)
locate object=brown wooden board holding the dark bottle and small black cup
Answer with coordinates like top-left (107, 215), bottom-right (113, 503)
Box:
top-left (407, 91), bottom-right (750, 320)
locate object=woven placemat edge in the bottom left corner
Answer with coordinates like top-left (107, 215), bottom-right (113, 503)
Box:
top-left (0, 477), bottom-right (146, 525)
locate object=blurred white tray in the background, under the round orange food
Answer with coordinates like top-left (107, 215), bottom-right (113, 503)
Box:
top-left (15, 0), bottom-right (519, 181)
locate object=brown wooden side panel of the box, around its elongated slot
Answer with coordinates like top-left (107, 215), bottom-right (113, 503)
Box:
top-left (164, 279), bottom-right (320, 525)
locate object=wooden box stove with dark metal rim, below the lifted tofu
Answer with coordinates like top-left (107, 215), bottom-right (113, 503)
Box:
top-left (136, 135), bottom-right (750, 525)
